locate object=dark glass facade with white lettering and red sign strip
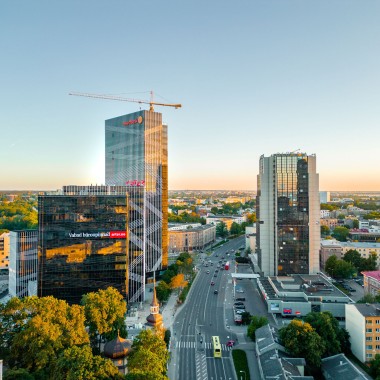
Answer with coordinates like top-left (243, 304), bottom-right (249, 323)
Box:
top-left (38, 195), bottom-right (129, 304)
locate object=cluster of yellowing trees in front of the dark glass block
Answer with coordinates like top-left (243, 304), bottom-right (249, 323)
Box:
top-left (0, 288), bottom-right (126, 379)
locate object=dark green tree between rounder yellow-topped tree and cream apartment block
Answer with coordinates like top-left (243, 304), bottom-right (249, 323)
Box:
top-left (304, 311), bottom-right (341, 356)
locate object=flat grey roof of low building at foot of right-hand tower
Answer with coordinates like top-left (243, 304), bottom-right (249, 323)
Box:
top-left (260, 274), bottom-right (349, 301)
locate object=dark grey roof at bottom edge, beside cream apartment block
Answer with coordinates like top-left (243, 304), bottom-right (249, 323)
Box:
top-left (322, 354), bottom-right (367, 380)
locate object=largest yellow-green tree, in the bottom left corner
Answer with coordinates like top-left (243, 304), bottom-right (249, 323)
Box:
top-left (3, 297), bottom-right (89, 373)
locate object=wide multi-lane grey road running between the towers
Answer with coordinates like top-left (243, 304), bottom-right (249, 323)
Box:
top-left (172, 236), bottom-right (245, 380)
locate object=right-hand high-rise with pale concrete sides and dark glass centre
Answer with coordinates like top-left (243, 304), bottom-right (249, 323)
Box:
top-left (256, 153), bottom-right (320, 276)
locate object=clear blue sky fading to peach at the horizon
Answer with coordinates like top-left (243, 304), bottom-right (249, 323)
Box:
top-left (0, 0), bottom-right (380, 191)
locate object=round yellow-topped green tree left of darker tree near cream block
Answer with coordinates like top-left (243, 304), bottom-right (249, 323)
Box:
top-left (279, 319), bottom-right (325, 368)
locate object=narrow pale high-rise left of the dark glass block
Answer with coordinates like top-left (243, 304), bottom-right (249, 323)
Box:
top-left (9, 230), bottom-right (38, 298)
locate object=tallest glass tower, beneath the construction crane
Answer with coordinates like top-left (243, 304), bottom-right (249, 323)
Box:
top-left (105, 111), bottom-right (168, 281)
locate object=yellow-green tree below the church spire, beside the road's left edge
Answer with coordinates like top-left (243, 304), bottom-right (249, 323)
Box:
top-left (128, 330), bottom-right (169, 378)
